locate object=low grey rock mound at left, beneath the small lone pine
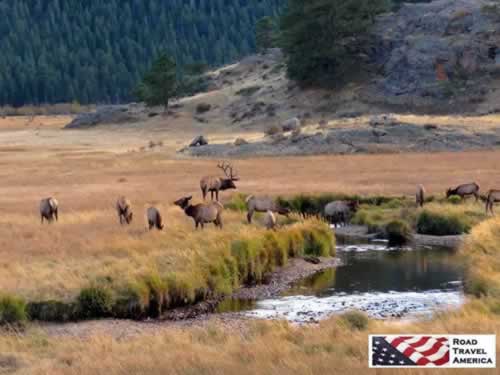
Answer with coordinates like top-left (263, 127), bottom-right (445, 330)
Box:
top-left (64, 105), bottom-right (138, 129)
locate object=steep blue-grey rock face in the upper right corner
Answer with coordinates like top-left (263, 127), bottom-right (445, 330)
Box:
top-left (371, 0), bottom-right (500, 98)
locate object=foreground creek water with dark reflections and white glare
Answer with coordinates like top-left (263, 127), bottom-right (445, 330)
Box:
top-left (219, 242), bottom-right (463, 322)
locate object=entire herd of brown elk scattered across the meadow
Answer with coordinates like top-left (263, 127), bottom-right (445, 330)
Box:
top-left (40, 162), bottom-right (500, 230)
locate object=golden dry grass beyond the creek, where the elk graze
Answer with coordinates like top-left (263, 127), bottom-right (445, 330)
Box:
top-left (0, 125), bottom-right (500, 298)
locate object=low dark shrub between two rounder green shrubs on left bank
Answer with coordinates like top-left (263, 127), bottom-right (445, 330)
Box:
top-left (26, 300), bottom-right (79, 323)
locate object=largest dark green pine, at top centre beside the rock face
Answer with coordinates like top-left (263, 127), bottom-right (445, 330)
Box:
top-left (281, 0), bottom-right (390, 84)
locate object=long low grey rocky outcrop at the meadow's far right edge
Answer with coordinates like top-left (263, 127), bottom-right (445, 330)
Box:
top-left (179, 122), bottom-right (500, 157)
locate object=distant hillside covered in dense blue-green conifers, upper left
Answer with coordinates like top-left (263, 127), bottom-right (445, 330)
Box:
top-left (0, 0), bottom-right (284, 105)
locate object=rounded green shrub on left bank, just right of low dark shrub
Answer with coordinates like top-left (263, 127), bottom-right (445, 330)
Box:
top-left (77, 286), bottom-right (114, 319)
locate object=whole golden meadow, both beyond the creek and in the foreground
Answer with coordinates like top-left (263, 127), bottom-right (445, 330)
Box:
top-left (0, 116), bottom-right (500, 374)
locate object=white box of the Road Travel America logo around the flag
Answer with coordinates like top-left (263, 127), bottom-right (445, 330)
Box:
top-left (368, 333), bottom-right (496, 369)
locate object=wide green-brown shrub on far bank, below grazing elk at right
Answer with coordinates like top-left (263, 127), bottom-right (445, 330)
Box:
top-left (417, 210), bottom-right (470, 236)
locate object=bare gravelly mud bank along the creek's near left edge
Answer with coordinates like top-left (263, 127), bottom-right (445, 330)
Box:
top-left (38, 258), bottom-right (340, 339)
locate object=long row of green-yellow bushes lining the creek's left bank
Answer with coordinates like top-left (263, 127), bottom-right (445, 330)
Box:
top-left (0, 220), bottom-right (335, 325)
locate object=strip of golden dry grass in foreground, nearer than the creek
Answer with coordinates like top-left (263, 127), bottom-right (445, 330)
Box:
top-left (0, 301), bottom-right (500, 375)
